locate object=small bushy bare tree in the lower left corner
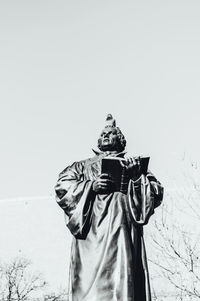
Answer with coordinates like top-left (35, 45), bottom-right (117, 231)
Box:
top-left (0, 258), bottom-right (46, 301)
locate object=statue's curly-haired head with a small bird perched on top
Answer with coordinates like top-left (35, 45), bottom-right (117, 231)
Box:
top-left (98, 114), bottom-right (126, 152)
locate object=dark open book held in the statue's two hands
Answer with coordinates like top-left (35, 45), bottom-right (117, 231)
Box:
top-left (101, 157), bottom-right (150, 193)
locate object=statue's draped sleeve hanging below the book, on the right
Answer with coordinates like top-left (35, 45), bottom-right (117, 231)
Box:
top-left (128, 172), bottom-right (163, 225)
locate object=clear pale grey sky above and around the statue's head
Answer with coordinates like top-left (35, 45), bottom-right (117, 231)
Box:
top-left (0, 0), bottom-right (200, 198)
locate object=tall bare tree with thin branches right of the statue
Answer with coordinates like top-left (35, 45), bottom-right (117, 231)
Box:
top-left (149, 161), bottom-right (200, 301)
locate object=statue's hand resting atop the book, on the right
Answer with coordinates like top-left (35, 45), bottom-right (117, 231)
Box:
top-left (121, 157), bottom-right (141, 180)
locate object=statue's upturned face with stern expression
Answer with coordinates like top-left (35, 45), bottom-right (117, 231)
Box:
top-left (98, 127), bottom-right (119, 151)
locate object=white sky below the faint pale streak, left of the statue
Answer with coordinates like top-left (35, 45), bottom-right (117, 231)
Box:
top-left (0, 198), bottom-right (71, 291)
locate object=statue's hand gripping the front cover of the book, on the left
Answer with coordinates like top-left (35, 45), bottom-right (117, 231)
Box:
top-left (92, 173), bottom-right (114, 194)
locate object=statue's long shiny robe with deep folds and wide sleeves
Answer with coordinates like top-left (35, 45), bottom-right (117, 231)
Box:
top-left (55, 153), bottom-right (163, 301)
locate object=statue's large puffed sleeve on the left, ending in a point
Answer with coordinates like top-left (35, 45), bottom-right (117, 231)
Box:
top-left (55, 161), bottom-right (94, 239)
